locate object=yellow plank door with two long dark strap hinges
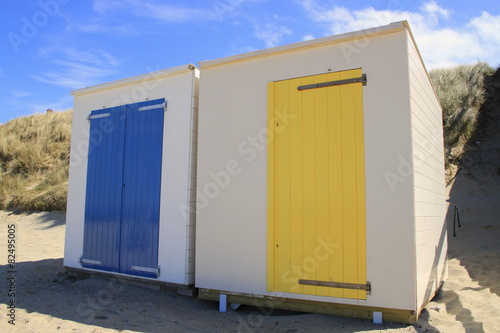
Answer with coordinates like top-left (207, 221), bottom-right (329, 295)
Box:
top-left (268, 69), bottom-right (369, 299)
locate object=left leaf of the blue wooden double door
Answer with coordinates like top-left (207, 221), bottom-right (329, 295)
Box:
top-left (82, 106), bottom-right (126, 272)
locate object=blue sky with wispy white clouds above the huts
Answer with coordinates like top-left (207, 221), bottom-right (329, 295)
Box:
top-left (0, 0), bottom-right (500, 123)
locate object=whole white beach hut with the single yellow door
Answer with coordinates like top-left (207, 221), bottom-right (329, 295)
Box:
top-left (196, 22), bottom-right (446, 322)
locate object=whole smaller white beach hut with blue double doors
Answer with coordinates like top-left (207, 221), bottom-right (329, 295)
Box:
top-left (64, 65), bottom-right (199, 285)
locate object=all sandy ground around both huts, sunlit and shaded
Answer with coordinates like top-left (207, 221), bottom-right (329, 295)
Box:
top-left (0, 170), bottom-right (500, 332)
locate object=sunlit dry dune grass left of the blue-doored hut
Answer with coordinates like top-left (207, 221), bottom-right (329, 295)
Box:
top-left (0, 110), bottom-right (72, 211)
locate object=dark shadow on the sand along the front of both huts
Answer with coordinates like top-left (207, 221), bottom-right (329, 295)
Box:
top-left (0, 258), bottom-right (420, 332)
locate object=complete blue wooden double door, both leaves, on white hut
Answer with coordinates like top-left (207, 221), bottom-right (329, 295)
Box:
top-left (82, 99), bottom-right (165, 277)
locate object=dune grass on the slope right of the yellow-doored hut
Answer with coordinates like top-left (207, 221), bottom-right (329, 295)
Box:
top-left (429, 62), bottom-right (494, 169)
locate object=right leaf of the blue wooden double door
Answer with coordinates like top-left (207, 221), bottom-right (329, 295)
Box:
top-left (120, 100), bottom-right (164, 277)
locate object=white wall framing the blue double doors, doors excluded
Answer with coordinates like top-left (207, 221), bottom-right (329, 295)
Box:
top-left (64, 66), bottom-right (198, 284)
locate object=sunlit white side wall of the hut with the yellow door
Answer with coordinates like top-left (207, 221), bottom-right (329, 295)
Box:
top-left (408, 31), bottom-right (448, 307)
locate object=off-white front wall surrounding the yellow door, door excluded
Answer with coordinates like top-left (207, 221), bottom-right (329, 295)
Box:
top-left (196, 28), bottom-right (416, 310)
